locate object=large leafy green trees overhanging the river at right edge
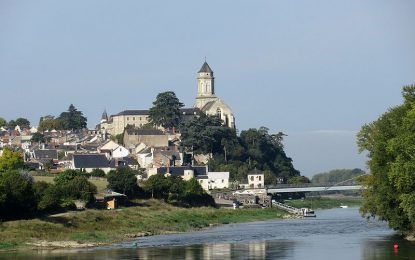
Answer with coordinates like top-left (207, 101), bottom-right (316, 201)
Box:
top-left (357, 85), bottom-right (415, 232)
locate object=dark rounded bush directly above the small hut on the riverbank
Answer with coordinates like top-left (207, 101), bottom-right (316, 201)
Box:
top-left (107, 167), bottom-right (140, 198)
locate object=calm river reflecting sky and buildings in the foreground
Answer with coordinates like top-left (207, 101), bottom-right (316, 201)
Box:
top-left (0, 208), bottom-right (415, 260)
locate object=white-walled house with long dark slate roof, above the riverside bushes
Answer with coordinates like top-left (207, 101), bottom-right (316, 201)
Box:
top-left (70, 154), bottom-right (116, 173)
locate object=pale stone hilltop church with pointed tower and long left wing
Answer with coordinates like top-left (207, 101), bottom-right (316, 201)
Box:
top-left (99, 61), bottom-right (235, 135)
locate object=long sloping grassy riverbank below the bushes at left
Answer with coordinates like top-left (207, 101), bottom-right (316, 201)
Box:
top-left (0, 200), bottom-right (286, 250)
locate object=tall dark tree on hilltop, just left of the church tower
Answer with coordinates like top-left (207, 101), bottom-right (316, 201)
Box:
top-left (149, 91), bottom-right (184, 130)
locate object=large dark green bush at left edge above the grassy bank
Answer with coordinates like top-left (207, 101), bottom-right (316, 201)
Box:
top-left (0, 170), bottom-right (37, 219)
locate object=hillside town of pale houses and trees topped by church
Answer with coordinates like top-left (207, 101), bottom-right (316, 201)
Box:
top-left (0, 62), bottom-right (309, 211)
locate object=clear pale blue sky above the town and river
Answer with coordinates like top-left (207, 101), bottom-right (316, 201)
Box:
top-left (0, 0), bottom-right (415, 176)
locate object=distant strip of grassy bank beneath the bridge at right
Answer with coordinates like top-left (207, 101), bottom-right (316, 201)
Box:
top-left (284, 196), bottom-right (362, 209)
